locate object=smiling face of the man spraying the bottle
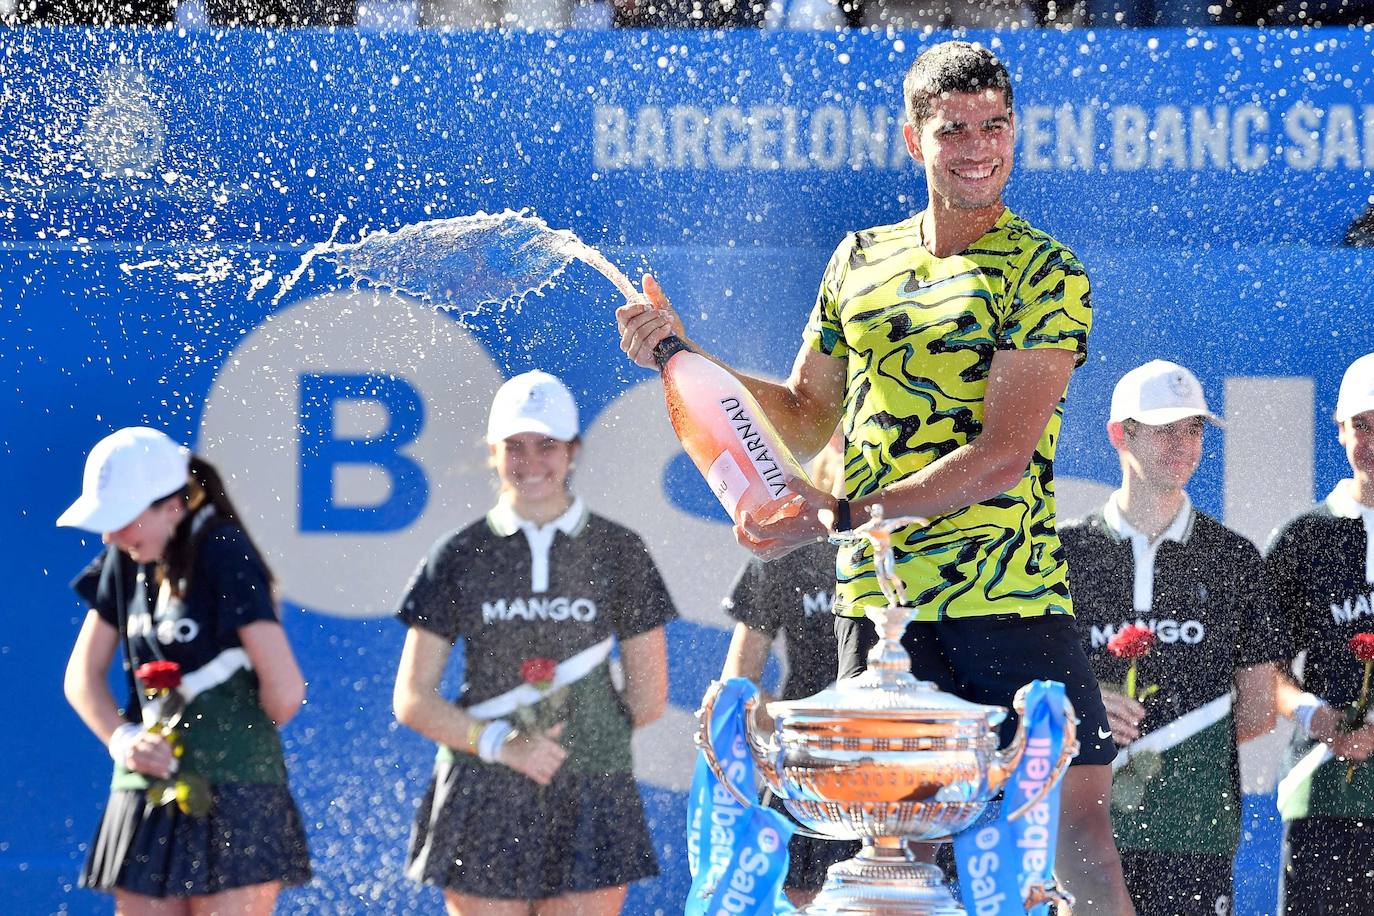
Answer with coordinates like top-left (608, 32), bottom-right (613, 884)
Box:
top-left (904, 89), bottom-right (1015, 210)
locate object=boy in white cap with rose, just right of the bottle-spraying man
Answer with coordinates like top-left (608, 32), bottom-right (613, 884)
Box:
top-left (1059, 360), bottom-right (1282, 916)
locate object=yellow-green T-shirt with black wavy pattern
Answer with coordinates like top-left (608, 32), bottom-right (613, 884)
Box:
top-left (805, 210), bottom-right (1092, 621)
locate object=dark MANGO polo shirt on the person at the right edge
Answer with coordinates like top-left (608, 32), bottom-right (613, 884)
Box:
top-left (1265, 488), bottom-right (1374, 817)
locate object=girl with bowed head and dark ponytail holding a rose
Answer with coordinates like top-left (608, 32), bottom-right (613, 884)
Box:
top-left (58, 427), bottom-right (311, 916)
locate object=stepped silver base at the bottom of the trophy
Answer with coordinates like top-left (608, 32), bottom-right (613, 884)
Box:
top-left (798, 840), bottom-right (966, 916)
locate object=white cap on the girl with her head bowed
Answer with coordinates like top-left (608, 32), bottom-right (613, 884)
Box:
top-left (58, 426), bottom-right (191, 534)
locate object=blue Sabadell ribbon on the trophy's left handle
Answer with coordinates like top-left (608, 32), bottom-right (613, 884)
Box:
top-left (684, 677), bottom-right (793, 916)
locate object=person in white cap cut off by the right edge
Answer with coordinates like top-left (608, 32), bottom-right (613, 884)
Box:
top-left (1265, 353), bottom-right (1374, 916)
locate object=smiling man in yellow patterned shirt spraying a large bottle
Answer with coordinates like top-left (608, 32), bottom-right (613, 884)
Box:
top-left (617, 41), bottom-right (1132, 915)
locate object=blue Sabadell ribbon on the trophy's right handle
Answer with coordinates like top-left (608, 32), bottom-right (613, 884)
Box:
top-left (954, 681), bottom-right (1065, 916)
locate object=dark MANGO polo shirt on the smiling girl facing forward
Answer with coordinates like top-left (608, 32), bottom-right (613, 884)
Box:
top-left (397, 500), bottom-right (676, 773)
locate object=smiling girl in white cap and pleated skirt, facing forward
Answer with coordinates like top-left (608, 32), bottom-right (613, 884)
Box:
top-left (393, 371), bottom-right (675, 916)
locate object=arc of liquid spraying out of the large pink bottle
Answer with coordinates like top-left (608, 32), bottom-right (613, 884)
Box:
top-left (272, 210), bottom-right (639, 312)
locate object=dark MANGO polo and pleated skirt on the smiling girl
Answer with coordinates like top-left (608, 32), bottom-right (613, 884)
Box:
top-left (397, 500), bottom-right (676, 900)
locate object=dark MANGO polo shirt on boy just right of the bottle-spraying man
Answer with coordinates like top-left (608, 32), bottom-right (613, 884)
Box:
top-left (1059, 494), bottom-right (1283, 862)
